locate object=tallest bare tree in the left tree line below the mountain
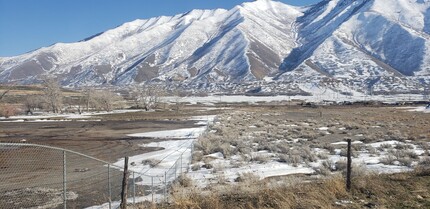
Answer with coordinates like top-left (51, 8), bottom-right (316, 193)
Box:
top-left (42, 77), bottom-right (63, 113)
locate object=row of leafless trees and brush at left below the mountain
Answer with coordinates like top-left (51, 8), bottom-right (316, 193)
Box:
top-left (0, 77), bottom-right (164, 118)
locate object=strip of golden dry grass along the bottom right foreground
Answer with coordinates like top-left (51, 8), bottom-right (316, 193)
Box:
top-left (165, 171), bottom-right (430, 209)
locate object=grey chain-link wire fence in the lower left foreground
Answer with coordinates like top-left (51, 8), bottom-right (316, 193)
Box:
top-left (0, 140), bottom-right (193, 209)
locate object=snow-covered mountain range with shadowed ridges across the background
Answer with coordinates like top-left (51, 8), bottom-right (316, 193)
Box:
top-left (0, 0), bottom-right (430, 94)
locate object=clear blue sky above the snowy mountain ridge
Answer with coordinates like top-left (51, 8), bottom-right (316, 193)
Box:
top-left (0, 0), bottom-right (319, 57)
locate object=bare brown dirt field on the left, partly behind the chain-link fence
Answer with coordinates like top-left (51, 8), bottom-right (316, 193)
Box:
top-left (0, 107), bottom-right (219, 208)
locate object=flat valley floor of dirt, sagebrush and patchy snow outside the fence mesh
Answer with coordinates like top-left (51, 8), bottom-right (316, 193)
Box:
top-left (0, 102), bottom-right (430, 208)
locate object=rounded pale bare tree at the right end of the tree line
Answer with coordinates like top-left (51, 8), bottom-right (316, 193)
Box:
top-left (131, 85), bottom-right (162, 111)
